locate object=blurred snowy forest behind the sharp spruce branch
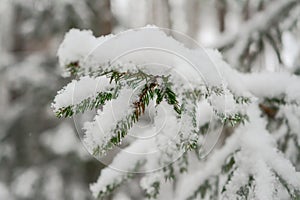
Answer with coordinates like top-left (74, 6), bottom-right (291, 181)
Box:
top-left (0, 0), bottom-right (300, 200)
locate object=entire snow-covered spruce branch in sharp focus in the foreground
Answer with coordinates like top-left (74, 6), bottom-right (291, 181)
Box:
top-left (52, 26), bottom-right (300, 200)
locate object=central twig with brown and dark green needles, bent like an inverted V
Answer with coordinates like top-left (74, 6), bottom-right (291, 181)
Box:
top-left (93, 71), bottom-right (181, 156)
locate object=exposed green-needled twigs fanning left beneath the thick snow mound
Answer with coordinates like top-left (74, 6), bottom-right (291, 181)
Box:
top-left (56, 68), bottom-right (182, 155)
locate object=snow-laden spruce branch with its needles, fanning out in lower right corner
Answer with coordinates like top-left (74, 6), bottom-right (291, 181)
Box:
top-left (179, 106), bottom-right (300, 199)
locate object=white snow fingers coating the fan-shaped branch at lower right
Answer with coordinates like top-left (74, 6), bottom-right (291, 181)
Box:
top-left (178, 105), bottom-right (300, 200)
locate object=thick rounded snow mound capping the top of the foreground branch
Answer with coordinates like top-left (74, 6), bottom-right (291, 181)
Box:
top-left (58, 26), bottom-right (227, 85)
